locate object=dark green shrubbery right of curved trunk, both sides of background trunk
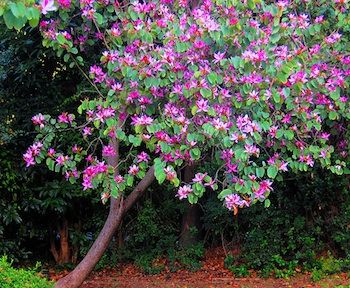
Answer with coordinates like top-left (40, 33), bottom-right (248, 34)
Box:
top-left (81, 171), bottom-right (350, 279)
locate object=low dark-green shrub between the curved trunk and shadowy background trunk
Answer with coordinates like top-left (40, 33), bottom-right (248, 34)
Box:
top-left (93, 197), bottom-right (204, 274)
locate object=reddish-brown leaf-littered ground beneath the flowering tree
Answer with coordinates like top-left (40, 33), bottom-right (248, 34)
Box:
top-left (52, 250), bottom-right (350, 288)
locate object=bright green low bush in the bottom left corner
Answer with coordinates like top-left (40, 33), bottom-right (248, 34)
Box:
top-left (0, 256), bottom-right (53, 288)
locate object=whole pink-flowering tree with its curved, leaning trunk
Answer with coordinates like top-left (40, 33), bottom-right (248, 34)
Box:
top-left (0, 0), bottom-right (350, 287)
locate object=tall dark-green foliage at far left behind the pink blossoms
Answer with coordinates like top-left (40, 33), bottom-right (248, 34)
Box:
top-left (0, 25), bottom-right (92, 262)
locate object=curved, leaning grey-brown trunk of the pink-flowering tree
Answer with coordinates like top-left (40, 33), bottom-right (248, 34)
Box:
top-left (55, 166), bottom-right (154, 288)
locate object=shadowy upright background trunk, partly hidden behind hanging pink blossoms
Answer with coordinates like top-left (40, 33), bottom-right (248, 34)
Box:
top-left (180, 165), bottom-right (201, 247)
